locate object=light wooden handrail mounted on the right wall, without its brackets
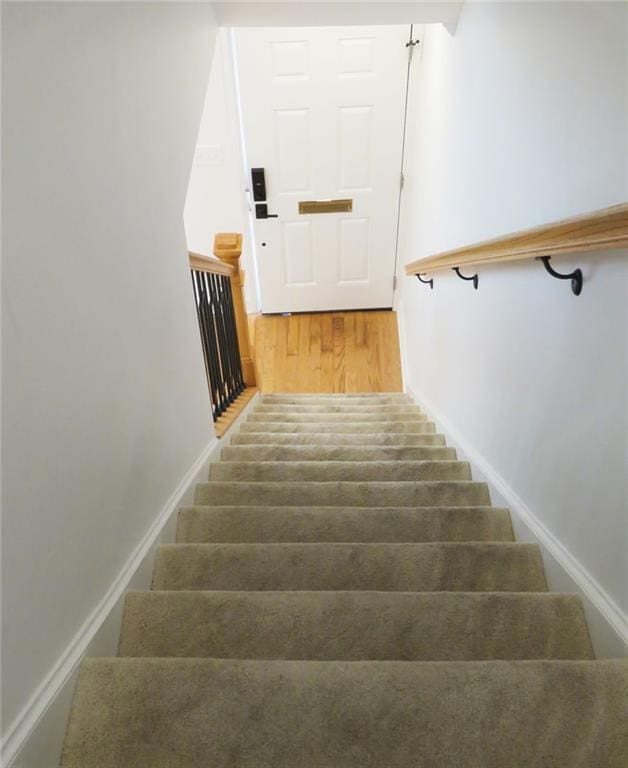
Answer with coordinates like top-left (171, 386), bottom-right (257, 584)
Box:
top-left (406, 203), bottom-right (628, 275)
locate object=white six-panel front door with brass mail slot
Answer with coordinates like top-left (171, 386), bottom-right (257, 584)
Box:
top-left (234, 26), bottom-right (410, 312)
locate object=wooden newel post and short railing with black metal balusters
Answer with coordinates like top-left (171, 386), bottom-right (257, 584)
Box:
top-left (189, 234), bottom-right (255, 421)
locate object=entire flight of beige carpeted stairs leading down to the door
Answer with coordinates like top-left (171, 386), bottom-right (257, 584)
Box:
top-left (62, 394), bottom-right (628, 768)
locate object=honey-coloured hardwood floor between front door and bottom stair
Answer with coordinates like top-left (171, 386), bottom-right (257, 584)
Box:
top-left (249, 311), bottom-right (401, 393)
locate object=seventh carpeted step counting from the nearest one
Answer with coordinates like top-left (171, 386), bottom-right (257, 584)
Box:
top-left (220, 445), bottom-right (456, 462)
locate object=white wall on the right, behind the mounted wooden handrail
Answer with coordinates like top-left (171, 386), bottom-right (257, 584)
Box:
top-left (399, 3), bottom-right (628, 648)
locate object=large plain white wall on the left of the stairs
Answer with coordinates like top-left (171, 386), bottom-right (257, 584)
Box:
top-left (2, 3), bottom-right (215, 752)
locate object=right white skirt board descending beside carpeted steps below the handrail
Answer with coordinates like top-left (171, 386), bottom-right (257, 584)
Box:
top-left (406, 386), bottom-right (628, 658)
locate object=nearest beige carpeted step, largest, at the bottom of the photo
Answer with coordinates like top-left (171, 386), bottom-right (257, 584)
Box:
top-left (62, 658), bottom-right (628, 768)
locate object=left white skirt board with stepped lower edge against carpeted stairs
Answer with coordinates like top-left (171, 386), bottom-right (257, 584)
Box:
top-left (1, 393), bottom-right (259, 768)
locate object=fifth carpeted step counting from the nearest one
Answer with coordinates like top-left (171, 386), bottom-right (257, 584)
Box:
top-left (194, 480), bottom-right (490, 507)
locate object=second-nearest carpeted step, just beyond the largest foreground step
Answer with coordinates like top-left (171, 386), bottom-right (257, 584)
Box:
top-left (118, 592), bottom-right (592, 661)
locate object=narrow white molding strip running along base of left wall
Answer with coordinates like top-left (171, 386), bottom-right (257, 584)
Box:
top-left (1, 436), bottom-right (220, 766)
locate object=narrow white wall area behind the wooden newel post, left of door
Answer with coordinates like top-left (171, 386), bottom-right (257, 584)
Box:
top-left (184, 29), bottom-right (259, 312)
